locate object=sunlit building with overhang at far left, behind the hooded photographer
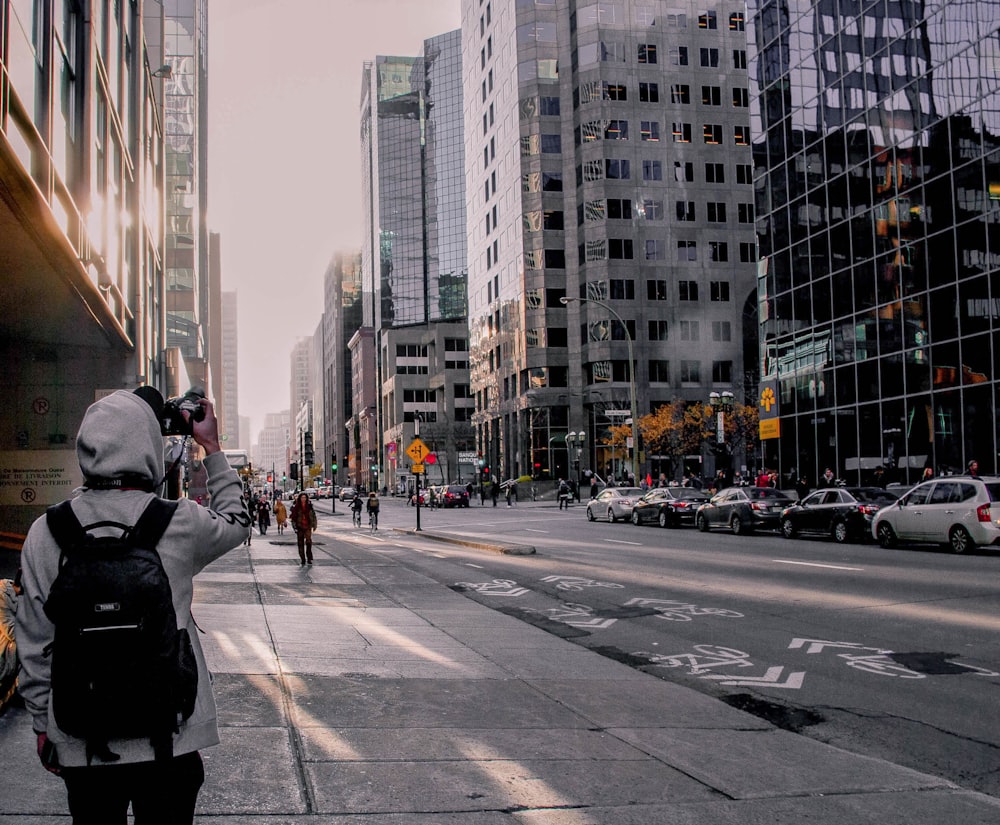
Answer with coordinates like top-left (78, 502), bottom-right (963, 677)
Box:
top-left (0, 0), bottom-right (170, 536)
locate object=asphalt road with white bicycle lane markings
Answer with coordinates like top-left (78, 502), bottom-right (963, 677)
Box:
top-left (318, 500), bottom-right (1000, 797)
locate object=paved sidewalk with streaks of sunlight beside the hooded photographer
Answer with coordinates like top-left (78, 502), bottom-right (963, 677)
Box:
top-left (0, 521), bottom-right (1000, 825)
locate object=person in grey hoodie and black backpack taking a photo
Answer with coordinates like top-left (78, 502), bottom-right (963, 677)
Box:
top-left (15, 387), bottom-right (251, 825)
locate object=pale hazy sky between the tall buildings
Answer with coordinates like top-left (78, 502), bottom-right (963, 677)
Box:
top-left (208, 0), bottom-right (461, 441)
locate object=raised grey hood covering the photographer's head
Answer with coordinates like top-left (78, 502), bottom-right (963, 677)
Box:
top-left (76, 390), bottom-right (163, 484)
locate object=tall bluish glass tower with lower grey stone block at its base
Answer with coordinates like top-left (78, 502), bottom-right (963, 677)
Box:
top-left (362, 30), bottom-right (475, 489)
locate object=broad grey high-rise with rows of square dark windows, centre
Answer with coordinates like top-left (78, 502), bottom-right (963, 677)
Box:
top-left (462, 0), bottom-right (756, 478)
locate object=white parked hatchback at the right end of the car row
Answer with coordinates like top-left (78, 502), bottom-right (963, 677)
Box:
top-left (872, 476), bottom-right (1000, 553)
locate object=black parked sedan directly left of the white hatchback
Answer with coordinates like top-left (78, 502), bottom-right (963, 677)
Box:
top-left (781, 487), bottom-right (899, 542)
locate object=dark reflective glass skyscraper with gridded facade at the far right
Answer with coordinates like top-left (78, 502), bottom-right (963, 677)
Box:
top-left (747, 0), bottom-right (1000, 483)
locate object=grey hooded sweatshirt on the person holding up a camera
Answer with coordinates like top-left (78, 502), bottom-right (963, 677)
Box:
top-left (15, 390), bottom-right (250, 767)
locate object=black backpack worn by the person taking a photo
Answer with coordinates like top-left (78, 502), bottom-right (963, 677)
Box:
top-left (45, 498), bottom-right (198, 765)
